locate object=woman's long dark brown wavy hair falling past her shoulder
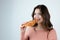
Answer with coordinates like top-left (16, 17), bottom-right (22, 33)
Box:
top-left (32, 5), bottom-right (53, 30)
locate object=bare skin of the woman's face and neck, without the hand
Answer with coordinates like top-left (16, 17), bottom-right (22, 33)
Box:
top-left (34, 9), bottom-right (43, 30)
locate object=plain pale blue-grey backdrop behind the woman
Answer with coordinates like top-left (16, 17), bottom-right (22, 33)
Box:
top-left (0, 0), bottom-right (60, 40)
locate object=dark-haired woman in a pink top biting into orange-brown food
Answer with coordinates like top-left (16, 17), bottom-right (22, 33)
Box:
top-left (21, 5), bottom-right (57, 40)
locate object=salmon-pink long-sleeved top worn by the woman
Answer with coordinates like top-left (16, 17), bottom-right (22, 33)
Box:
top-left (21, 27), bottom-right (57, 40)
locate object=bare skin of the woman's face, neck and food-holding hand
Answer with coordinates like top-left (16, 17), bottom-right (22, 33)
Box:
top-left (20, 9), bottom-right (43, 32)
